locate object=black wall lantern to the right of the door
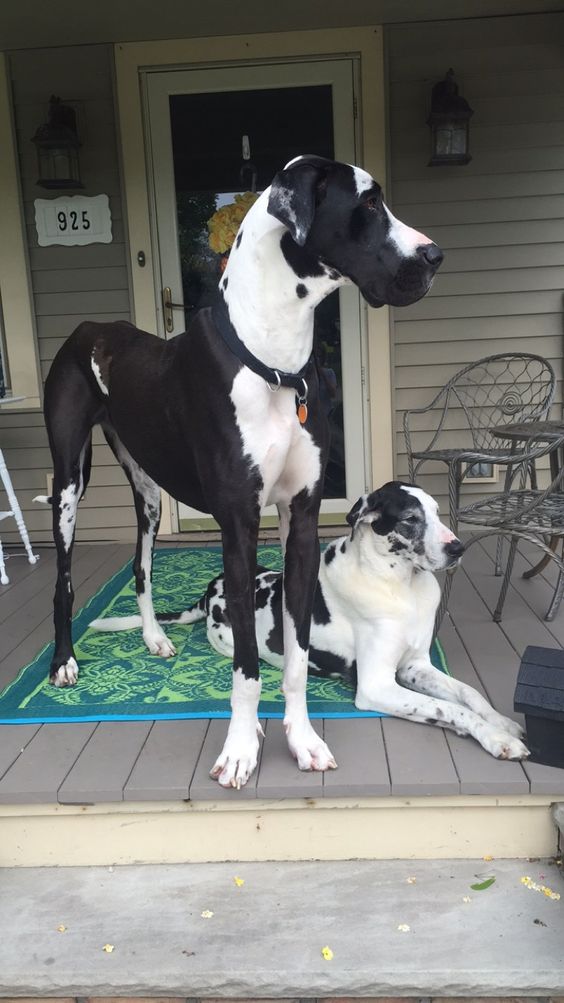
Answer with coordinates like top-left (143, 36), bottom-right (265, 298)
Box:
top-left (427, 69), bottom-right (474, 166)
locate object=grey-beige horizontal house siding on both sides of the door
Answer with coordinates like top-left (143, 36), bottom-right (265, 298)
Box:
top-left (0, 14), bottom-right (564, 543)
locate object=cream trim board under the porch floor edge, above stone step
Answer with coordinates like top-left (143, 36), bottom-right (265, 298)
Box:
top-left (0, 792), bottom-right (558, 867)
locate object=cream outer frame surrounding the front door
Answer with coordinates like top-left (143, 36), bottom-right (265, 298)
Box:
top-left (114, 26), bottom-right (393, 534)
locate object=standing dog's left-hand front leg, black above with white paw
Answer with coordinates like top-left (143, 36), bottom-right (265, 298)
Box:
top-left (210, 516), bottom-right (262, 788)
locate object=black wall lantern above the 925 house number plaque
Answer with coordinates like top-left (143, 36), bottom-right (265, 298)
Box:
top-left (31, 94), bottom-right (84, 189)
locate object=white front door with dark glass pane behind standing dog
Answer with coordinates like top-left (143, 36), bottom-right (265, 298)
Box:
top-left (144, 58), bottom-right (369, 530)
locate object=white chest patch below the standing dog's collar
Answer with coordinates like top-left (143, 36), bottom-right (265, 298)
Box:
top-left (231, 369), bottom-right (321, 506)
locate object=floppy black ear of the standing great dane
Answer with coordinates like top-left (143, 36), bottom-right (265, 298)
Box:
top-left (268, 156), bottom-right (331, 247)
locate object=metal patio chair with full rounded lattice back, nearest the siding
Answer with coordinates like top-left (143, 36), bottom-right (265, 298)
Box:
top-left (403, 352), bottom-right (556, 629)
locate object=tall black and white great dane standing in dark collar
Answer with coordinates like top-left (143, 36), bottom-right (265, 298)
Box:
top-left (41, 156), bottom-right (443, 786)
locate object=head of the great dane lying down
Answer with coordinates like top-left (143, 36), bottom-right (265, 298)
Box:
top-left (346, 480), bottom-right (464, 572)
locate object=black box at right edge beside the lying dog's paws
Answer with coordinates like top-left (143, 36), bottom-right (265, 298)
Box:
top-left (514, 645), bottom-right (564, 769)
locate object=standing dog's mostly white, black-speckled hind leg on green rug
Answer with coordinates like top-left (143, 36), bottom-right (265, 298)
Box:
top-left (102, 424), bottom-right (176, 658)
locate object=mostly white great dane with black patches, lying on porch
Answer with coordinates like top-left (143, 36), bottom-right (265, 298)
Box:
top-left (90, 480), bottom-right (529, 759)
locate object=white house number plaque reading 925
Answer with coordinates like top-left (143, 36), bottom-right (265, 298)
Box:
top-left (34, 195), bottom-right (111, 248)
